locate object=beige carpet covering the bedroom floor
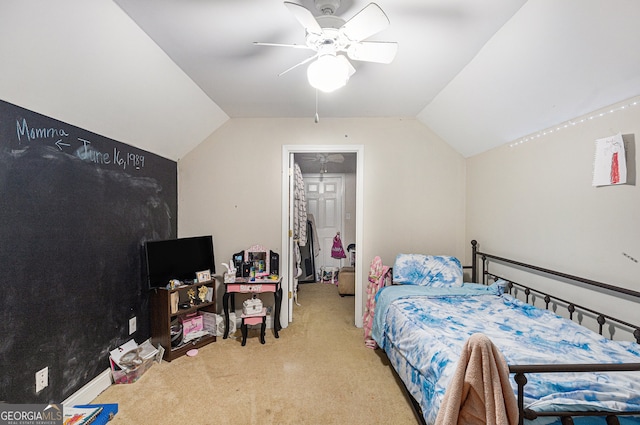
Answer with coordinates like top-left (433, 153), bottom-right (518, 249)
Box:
top-left (94, 283), bottom-right (417, 425)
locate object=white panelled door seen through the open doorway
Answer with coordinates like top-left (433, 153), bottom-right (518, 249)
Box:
top-left (303, 174), bottom-right (344, 274)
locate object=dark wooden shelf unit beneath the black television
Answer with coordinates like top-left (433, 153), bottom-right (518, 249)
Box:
top-left (150, 280), bottom-right (216, 362)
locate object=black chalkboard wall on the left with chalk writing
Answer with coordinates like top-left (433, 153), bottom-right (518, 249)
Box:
top-left (0, 101), bottom-right (177, 403)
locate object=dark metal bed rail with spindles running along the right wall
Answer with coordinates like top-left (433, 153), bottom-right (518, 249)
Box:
top-left (471, 240), bottom-right (640, 344)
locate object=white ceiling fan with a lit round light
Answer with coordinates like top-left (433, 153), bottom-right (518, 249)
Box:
top-left (254, 0), bottom-right (398, 92)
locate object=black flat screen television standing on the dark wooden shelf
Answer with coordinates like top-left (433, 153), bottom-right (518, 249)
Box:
top-left (144, 235), bottom-right (216, 289)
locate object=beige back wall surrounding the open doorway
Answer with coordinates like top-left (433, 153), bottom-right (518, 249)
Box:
top-left (178, 118), bottom-right (467, 322)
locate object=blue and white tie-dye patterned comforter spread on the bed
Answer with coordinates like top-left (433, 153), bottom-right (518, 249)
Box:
top-left (372, 283), bottom-right (640, 424)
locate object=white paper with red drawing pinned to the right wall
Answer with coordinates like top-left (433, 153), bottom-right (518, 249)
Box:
top-left (593, 133), bottom-right (627, 186)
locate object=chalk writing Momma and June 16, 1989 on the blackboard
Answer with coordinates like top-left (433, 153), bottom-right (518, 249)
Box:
top-left (16, 118), bottom-right (145, 170)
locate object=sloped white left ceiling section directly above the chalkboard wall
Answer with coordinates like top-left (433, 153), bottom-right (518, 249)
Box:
top-left (0, 0), bottom-right (229, 160)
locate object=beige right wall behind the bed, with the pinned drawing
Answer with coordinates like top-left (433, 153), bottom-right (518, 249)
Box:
top-left (466, 98), bottom-right (640, 332)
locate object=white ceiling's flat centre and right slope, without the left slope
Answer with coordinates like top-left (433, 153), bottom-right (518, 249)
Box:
top-left (116, 0), bottom-right (640, 156)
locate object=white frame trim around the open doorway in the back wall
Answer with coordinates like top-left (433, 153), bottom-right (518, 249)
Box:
top-left (280, 145), bottom-right (364, 327)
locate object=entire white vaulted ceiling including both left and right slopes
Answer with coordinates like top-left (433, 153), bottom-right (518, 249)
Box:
top-left (0, 0), bottom-right (640, 159)
